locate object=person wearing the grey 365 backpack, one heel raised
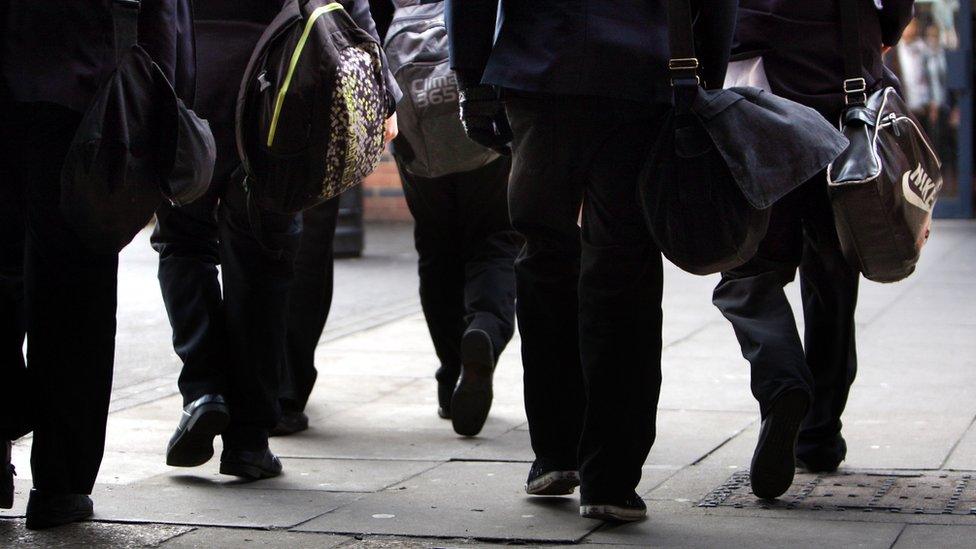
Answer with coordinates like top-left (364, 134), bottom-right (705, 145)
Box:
top-left (371, 0), bottom-right (520, 436)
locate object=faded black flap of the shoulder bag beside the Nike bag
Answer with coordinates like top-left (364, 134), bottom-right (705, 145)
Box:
top-left (692, 87), bottom-right (848, 209)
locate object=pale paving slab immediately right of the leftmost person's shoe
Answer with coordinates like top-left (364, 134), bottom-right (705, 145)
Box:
top-left (92, 479), bottom-right (357, 528)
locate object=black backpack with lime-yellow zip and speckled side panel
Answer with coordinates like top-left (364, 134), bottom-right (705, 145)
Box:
top-left (235, 0), bottom-right (387, 214)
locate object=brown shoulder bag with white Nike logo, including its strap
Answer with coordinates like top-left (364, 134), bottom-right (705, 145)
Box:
top-left (827, 0), bottom-right (942, 282)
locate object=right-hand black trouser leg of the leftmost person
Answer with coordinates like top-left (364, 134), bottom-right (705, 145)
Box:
top-left (4, 104), bottom-right (118, 494)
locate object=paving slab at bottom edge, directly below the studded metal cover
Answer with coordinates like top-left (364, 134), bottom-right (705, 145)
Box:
top-left (586, 513), bottom-right (902, 549)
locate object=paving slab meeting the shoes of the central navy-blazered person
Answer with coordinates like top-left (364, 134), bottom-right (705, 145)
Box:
top-left (296, 462), bottom-right (600, 542)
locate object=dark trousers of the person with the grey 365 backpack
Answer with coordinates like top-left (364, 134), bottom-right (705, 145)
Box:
top-left (398, 158), bottom-right (521, 384)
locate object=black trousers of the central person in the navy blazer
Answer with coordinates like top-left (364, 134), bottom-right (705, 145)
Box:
top-left (506, 95), bottom-right (663, 502)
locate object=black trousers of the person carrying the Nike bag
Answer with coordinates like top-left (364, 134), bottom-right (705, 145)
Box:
top-left (713, 174), bottom-right (858, 460)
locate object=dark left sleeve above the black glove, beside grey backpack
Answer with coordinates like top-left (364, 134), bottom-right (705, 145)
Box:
top-left (445, 0), bottom-right (498, 83)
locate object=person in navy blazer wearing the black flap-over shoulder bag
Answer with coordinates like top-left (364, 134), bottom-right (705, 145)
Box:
top-left (448, 0), bottom-right (735, 520)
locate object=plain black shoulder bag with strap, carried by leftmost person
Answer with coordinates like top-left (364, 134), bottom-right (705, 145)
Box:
top-left (60, 0), bottom-right (217, 253)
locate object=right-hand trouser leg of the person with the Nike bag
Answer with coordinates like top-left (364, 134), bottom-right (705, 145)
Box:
top-left (797, 183), bottom-right (860, 463)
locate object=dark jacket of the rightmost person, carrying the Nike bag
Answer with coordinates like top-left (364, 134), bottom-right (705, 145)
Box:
top-left (733, 0), bottom-right (914, 118)
